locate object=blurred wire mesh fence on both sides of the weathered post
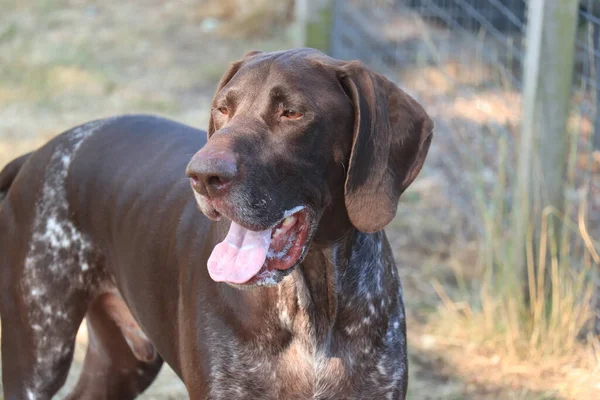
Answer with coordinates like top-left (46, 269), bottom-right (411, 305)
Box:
top-left (330, 0), bottom-right (600, 332)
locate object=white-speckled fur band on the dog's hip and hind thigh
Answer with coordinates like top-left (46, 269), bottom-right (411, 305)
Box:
top-left (21, 120), bottom-right (106, 399)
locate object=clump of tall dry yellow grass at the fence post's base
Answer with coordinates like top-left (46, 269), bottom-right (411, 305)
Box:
top-left (416, 194), bottom-right (600, 399)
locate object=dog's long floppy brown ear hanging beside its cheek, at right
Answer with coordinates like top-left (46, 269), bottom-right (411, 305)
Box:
top-left (338, 61), bottom-right (433, 232)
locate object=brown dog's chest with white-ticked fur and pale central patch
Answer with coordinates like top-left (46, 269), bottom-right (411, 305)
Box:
top-left (206, 241), bottom-right (406, 399)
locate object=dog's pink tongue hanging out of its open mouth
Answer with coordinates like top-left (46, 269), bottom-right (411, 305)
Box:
top-left (208, 222), bottom-right (271, 284)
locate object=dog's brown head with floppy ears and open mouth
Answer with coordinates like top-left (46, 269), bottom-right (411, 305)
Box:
top-left (187, 49), bottom-right (433, 285)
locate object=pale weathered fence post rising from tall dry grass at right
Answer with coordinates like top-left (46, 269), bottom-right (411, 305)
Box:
top-left (513, 0), bottom-right (578, 296)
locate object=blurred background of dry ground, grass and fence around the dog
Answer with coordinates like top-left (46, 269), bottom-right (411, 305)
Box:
top-left (0, 0), bottom-right (600, 400)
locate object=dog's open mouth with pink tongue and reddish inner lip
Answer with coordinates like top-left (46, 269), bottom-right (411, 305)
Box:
top-left (208, 206), bottom-right (310, 286)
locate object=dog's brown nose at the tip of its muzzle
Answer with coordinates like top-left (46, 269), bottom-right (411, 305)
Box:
top-left (186, 151), bottom-right (237, 197)
